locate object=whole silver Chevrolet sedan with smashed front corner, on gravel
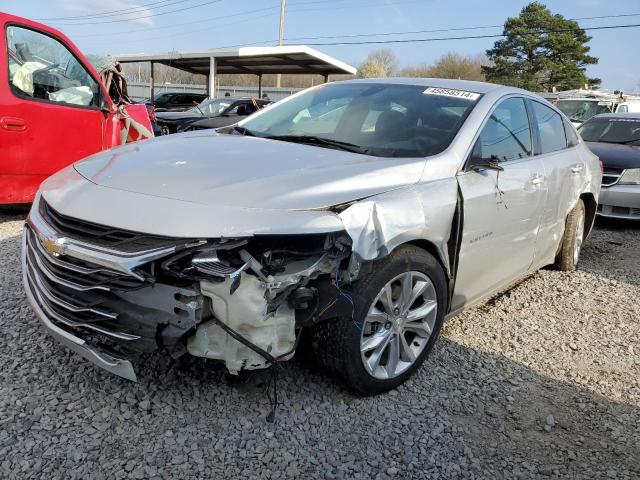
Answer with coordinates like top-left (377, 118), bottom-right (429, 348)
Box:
top-left (23, 79), bottom-right (601, 395)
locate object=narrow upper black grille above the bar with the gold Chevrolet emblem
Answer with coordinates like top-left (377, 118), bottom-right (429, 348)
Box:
top-left (39, 199), bottom-right (188, 253)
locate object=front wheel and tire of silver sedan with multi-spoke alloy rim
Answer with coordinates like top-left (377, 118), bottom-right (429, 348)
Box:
top-left (310, 245), bottom-right (447, 396)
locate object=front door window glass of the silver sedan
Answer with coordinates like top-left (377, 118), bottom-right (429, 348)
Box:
top-left (473, 98), bottom-right (531, 162)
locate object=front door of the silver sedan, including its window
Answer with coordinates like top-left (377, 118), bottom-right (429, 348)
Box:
top-left (452, 97), bottom-right (547, 310)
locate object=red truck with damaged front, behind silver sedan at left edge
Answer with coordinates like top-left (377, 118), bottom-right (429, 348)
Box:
top-left (0, 12), bottom-right (153, 204)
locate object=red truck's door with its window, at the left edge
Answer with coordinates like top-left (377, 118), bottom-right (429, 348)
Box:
top-left (0, 25), bottom-right (105, 203)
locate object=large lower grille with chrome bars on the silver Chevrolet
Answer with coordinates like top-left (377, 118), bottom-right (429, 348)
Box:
top-left (25, 226), bottom-right (145, 340)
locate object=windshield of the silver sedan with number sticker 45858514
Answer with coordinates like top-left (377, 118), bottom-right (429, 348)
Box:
top-left (242, 83), bottom-right (480, 157)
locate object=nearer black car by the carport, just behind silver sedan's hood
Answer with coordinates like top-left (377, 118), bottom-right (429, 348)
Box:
top-left (159, 97), bottom-right (273, 135)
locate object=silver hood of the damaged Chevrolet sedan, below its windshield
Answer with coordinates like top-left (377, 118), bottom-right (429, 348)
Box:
top-left (75, 132), bottom-right (425, 210)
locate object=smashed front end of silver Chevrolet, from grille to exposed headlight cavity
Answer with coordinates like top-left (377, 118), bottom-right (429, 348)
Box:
top-left (23, 199), bottom-right (359, 380)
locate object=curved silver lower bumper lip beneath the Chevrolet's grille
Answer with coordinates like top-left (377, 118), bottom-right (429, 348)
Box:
top-left (22, 234), bottom-right (137, 382)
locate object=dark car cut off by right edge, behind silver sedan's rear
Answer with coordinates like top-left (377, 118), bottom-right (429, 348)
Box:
top-left (579, 113), bottom-right (640, 220)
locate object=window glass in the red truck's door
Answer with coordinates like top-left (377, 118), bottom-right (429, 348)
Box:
top-left (6, 26), bottom-right (99, 106)
